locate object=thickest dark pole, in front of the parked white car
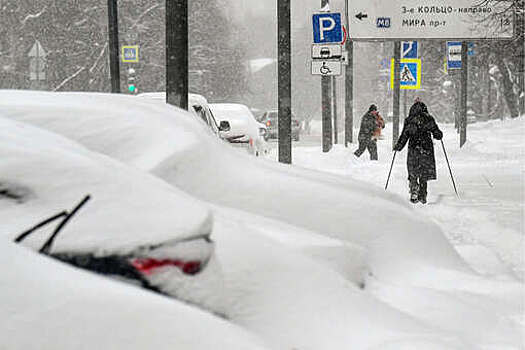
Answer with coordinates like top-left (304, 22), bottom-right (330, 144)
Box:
top-left (166, 0), bottom-right (188, 110)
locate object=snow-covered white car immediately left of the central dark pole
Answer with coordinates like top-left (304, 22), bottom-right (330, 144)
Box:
top-left (210, 103), bottom-right (268, 156)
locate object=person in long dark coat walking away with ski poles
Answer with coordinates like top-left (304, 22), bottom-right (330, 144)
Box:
top-left (394, 100), bottom-right (443, 204)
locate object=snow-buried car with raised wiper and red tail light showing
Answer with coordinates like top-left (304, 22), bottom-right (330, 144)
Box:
top-left (0, 118), bottom-right (214, 299)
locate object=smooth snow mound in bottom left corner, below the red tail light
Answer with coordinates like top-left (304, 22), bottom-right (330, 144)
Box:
top-left (0, 241), bottom-right (267, 350)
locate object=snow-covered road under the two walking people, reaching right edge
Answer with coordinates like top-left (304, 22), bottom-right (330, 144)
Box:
top-left (271, 119), bottom-right (525, 281)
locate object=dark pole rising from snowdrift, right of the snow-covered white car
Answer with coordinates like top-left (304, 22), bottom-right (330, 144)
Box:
top-left (277, 0), bottom-right (292, 164)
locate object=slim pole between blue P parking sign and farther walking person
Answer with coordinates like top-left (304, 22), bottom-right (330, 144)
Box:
top-left (345, 0), bottom-right (354, 147)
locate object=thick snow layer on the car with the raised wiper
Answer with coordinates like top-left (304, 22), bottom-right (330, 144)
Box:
top-left (0, 113), bottom-right (212, 254)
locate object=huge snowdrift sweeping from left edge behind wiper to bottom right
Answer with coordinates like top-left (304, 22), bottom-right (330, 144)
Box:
top-left (0, 91), bottom-right (523, 349)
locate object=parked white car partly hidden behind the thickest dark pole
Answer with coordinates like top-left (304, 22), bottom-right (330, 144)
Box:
top-left (137, 92), bottom-right (230, 138)
